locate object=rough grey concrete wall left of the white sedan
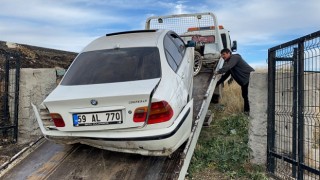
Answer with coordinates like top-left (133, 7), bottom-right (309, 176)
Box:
top-left (18, 68), bottom-right (57, 143)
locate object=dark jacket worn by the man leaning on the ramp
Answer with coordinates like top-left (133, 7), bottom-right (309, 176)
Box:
top-left (217, 54), bottom-right (254, 86)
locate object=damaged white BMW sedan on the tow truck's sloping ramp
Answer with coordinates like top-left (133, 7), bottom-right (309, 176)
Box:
top-left (32, 30), bottom-right (194, 156)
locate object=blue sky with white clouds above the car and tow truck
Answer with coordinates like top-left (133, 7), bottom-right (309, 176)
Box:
top-left (0, 0), bottom-right (320, 67)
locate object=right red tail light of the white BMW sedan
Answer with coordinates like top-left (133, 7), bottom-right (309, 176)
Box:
top-left (133, 101), bottom-right (173, 124)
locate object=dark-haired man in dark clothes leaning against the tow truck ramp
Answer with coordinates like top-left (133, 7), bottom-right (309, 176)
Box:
top-left (215, 49), bottom-right (254, 115)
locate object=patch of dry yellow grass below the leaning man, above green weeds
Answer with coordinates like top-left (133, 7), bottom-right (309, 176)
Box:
top-left (220, 81), bottom-right (243, 115)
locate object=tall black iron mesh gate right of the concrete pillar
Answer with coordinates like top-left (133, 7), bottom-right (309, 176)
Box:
top-left (267, 31), bottom-right (320, 180)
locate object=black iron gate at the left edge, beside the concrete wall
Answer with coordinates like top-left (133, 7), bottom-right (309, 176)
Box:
top-left (0, 49), bottom-right (20, 145)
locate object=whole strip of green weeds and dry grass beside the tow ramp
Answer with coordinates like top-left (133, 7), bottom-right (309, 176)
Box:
top-left (189, 81), bottom-right (267, 180)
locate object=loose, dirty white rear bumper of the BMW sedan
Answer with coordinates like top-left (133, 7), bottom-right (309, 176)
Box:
top-left (33, 100), bottom-right (193, 156)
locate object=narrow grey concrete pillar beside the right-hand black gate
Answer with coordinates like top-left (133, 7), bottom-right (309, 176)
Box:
top-left (249, 72), bottom-right (268, 165)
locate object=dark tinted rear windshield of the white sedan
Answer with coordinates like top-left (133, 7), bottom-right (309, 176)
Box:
top-left (61, 47), bottom-right (161, 85)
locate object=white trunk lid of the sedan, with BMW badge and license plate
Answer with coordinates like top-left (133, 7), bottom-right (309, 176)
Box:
top-left (44, 78), bottom-right (160, 131)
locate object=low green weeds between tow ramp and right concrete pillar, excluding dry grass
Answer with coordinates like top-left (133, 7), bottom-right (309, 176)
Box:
top-left (189, 114), bottom-right (264, 179)
